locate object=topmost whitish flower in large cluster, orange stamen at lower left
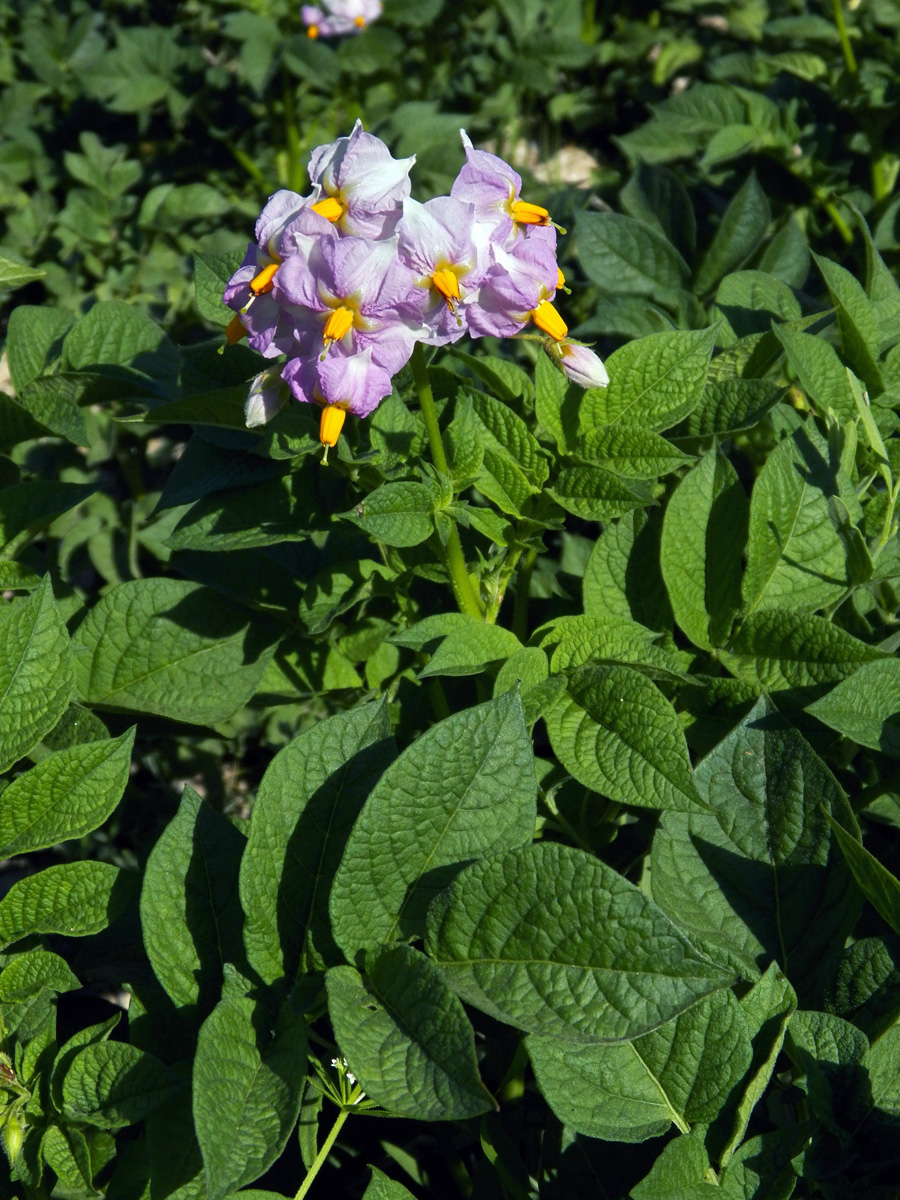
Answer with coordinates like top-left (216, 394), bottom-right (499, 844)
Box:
top-left (304, 121), bottom-right (415, 238)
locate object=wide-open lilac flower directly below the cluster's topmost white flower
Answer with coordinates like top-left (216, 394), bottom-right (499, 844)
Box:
top-left (277, 230), bottom-right (424, 374)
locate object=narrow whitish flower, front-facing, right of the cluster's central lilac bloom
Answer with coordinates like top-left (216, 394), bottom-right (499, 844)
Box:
top-left (397, 196), bottom-right (486, 346)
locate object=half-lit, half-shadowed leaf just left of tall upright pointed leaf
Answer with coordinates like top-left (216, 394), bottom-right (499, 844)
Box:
top-left (582, 509), bottom-right (673, 630)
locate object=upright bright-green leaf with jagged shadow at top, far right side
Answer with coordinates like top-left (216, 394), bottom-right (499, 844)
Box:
top-left (743, 427), bottom-right (852, 612)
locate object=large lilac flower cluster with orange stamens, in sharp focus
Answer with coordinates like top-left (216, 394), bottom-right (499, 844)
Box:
top-left (224, 121), bottom-right (607, 446)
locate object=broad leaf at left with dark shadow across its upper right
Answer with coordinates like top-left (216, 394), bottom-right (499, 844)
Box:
top-left (74, 577), bottom-right (272, 725)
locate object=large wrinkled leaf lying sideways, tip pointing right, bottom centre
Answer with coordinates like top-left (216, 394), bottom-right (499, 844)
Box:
top-left (426, 841), bottom-right (733, 1043)
